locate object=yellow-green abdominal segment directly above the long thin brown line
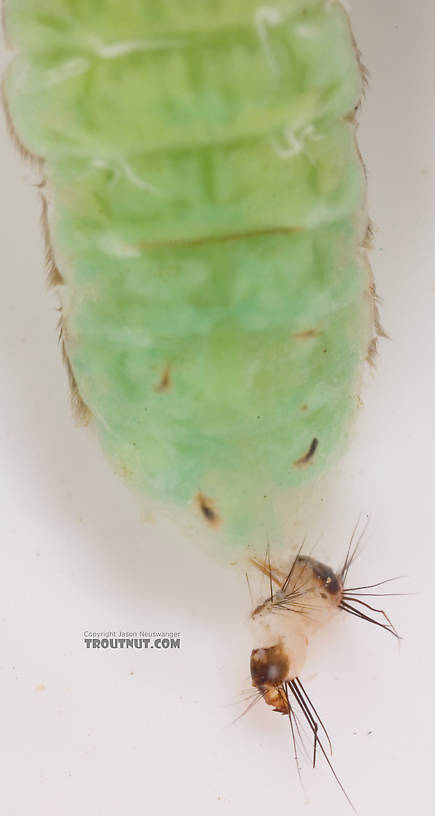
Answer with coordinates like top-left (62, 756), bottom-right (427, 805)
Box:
top-left (47, 121), bottom-right (364, 245)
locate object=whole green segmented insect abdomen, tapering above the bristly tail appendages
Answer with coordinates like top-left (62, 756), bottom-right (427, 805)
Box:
top-left (5, 0), bottom-right (375, 545)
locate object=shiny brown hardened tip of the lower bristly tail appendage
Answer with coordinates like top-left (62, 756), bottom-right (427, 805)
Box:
top-left (251, 643), bottom-right (289, 714)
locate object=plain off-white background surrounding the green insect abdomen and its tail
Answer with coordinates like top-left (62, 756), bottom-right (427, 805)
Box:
top-left (0, 0), bottom-right (435, 816)
